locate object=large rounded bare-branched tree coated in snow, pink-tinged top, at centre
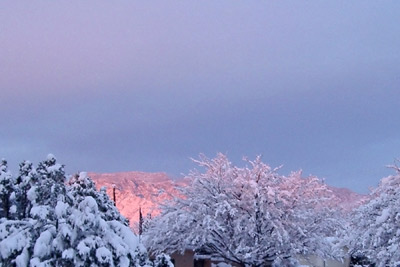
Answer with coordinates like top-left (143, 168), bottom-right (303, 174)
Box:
top-left (144, 154), bottom-right (342, 266)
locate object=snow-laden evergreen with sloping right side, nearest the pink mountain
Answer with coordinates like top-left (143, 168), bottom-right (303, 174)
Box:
top-left (58, 173), bottom-right (150, 266)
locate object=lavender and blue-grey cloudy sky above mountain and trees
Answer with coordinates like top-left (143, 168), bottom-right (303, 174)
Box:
top-left (0, 0), bottom-right (400, 193)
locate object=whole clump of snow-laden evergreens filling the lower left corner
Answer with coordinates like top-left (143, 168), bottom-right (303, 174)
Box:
top-left (0, 155), bottom-right (162, 267)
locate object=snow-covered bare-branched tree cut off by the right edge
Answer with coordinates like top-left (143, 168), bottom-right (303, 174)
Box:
top-left (349, 163), bottom-right (400, 267)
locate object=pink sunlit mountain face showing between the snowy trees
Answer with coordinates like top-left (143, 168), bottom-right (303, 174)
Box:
top-left (89, 172), bottom-right (366, 229)
